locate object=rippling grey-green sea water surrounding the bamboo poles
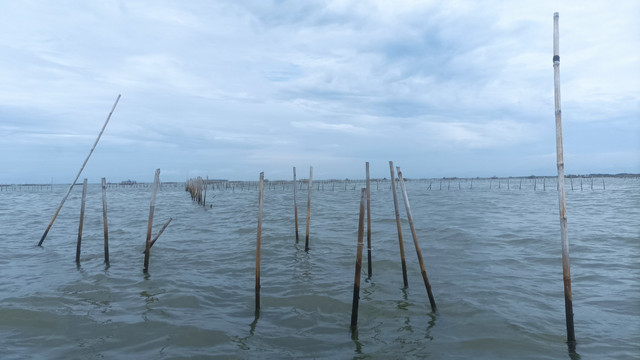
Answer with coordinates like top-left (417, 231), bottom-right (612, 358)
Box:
top-left (0, 178), bottom-right (640, 359)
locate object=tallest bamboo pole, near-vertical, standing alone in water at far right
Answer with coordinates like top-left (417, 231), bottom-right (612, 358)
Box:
top-left (553, 13), bottom-right (576, 348)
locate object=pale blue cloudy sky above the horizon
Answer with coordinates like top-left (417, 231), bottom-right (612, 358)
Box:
top-left (0, 0), bottom-right (640, 184)
